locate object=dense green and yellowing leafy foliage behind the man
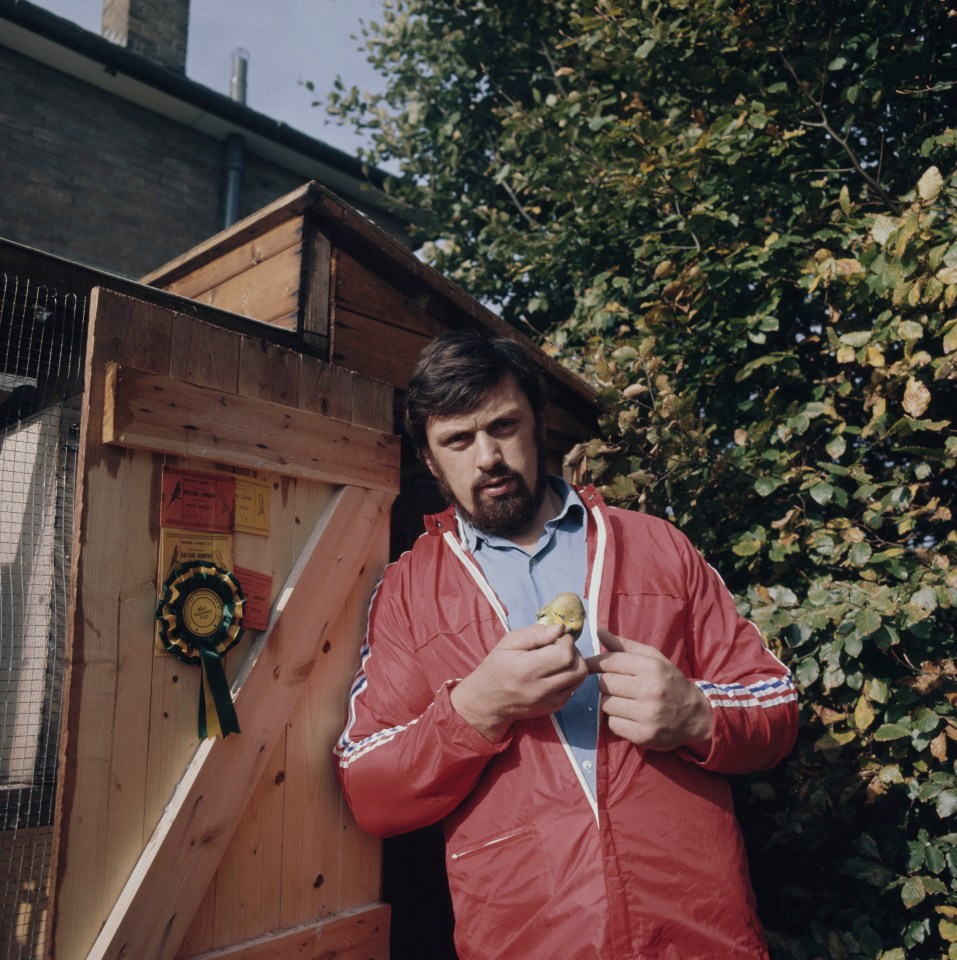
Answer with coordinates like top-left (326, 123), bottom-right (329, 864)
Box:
top-left (330, 0), bottom-right (957, 960)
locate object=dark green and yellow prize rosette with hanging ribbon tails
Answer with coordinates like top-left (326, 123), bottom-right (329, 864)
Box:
top-left (156, 560), bottom-right (246, 738)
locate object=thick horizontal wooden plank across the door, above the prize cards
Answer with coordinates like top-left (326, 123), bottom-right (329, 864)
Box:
top-left (103, 366), bottom-right (399, 491)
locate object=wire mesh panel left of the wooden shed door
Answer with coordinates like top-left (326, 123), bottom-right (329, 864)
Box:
top-left (0, 274), bottom-right (87, 960)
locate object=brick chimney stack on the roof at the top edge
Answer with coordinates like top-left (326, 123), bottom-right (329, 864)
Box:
top-left (102, 0), bottom-right (189, 74)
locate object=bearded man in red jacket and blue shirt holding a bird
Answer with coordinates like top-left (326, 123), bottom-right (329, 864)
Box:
top-left (337, 331), bottom-right (797, 960)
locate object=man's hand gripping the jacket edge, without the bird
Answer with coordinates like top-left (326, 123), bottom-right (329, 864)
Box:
top-left (588, 627), bottom-right (712, 757)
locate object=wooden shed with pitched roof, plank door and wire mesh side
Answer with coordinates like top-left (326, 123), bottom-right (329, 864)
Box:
top-left (0, 184), bottom-right (594, 960)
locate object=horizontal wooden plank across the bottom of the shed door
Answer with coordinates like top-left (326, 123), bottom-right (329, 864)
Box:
top-left (181, 903), bottom-right (389, 960)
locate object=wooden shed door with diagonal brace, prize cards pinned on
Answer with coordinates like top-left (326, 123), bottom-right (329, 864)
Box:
top-left (49, 288), bottom-right (399, 960)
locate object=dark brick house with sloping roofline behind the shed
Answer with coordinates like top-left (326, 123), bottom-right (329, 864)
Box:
top-left (0, 0), bottom-right (404, 278)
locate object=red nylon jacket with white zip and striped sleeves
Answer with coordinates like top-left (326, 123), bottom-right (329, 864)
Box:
top-left (336, 487), bottom-right (797, 960)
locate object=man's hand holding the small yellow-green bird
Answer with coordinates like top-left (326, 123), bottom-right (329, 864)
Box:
top-left (451, 624), bottom-right (588, 743)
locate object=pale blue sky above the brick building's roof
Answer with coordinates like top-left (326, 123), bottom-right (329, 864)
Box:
top-left (32, 0), bottom-right (384, 153)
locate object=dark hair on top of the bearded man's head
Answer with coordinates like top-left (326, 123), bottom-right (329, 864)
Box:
top-left (405, 330), bottom-right (545, 453)
